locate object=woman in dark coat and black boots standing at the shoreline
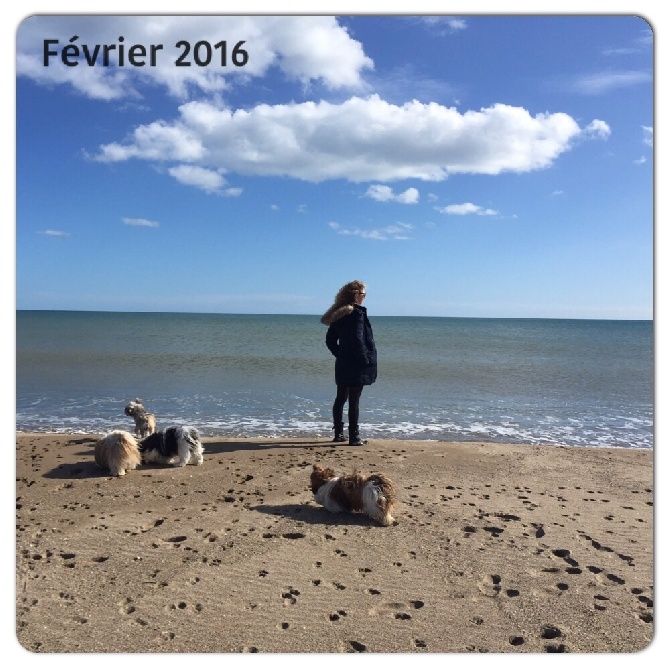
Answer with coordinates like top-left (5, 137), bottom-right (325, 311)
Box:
top-left (321, 279), bottom-right (377, 446)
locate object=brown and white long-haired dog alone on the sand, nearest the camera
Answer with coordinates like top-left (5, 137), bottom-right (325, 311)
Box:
top-left (310, 465), bottom-right (397, 526)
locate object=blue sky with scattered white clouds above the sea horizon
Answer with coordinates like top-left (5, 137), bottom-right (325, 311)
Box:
top-left (16, 9), bottom-right (654, 319)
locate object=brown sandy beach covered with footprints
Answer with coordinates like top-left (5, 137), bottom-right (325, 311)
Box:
top-left (16, 433), bottom-right (654, 654)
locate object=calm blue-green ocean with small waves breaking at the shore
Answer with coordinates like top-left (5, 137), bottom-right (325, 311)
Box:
top-left (16, 310), bottom-right (654, 449)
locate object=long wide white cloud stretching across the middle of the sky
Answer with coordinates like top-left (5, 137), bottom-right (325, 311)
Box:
top-left (95, 95), bottom-right (607, 184)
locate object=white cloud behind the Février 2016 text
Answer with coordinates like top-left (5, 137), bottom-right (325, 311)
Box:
top-left (16, 15), bottom-right (373, 100)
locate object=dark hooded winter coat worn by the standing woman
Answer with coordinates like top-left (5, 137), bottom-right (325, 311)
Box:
top-left (326, 305), bottom-right (377, 386)
